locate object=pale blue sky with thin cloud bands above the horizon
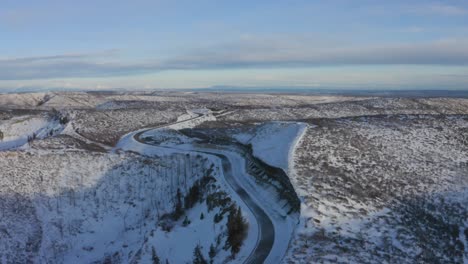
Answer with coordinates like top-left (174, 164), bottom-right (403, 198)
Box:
top-left (0, 0), bottom-right (468, 92)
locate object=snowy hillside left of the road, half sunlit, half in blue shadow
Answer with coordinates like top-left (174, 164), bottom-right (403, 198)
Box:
top-left (0, 147), bottom-right (252, 263)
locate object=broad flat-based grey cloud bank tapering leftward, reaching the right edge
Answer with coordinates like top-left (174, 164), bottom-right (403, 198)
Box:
top-left (166, 39), bottom-right (468, 68)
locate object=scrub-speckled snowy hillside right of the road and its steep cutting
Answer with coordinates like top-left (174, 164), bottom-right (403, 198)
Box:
top-left (289, 115), bottom-right (468, 263)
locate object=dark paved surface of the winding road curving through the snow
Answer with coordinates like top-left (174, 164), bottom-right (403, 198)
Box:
top-left (133, 110), bottom-right (275, 264)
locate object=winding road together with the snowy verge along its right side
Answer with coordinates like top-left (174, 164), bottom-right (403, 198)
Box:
top-left (115, 111), bottom-right (298, 263)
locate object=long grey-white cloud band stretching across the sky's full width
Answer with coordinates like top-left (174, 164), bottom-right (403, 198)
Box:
top-left (0, 36), bottom-right (468, 80)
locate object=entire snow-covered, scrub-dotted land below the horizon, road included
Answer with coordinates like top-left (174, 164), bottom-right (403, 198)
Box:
top-left (0, 91), bottom-right (468, 264)
